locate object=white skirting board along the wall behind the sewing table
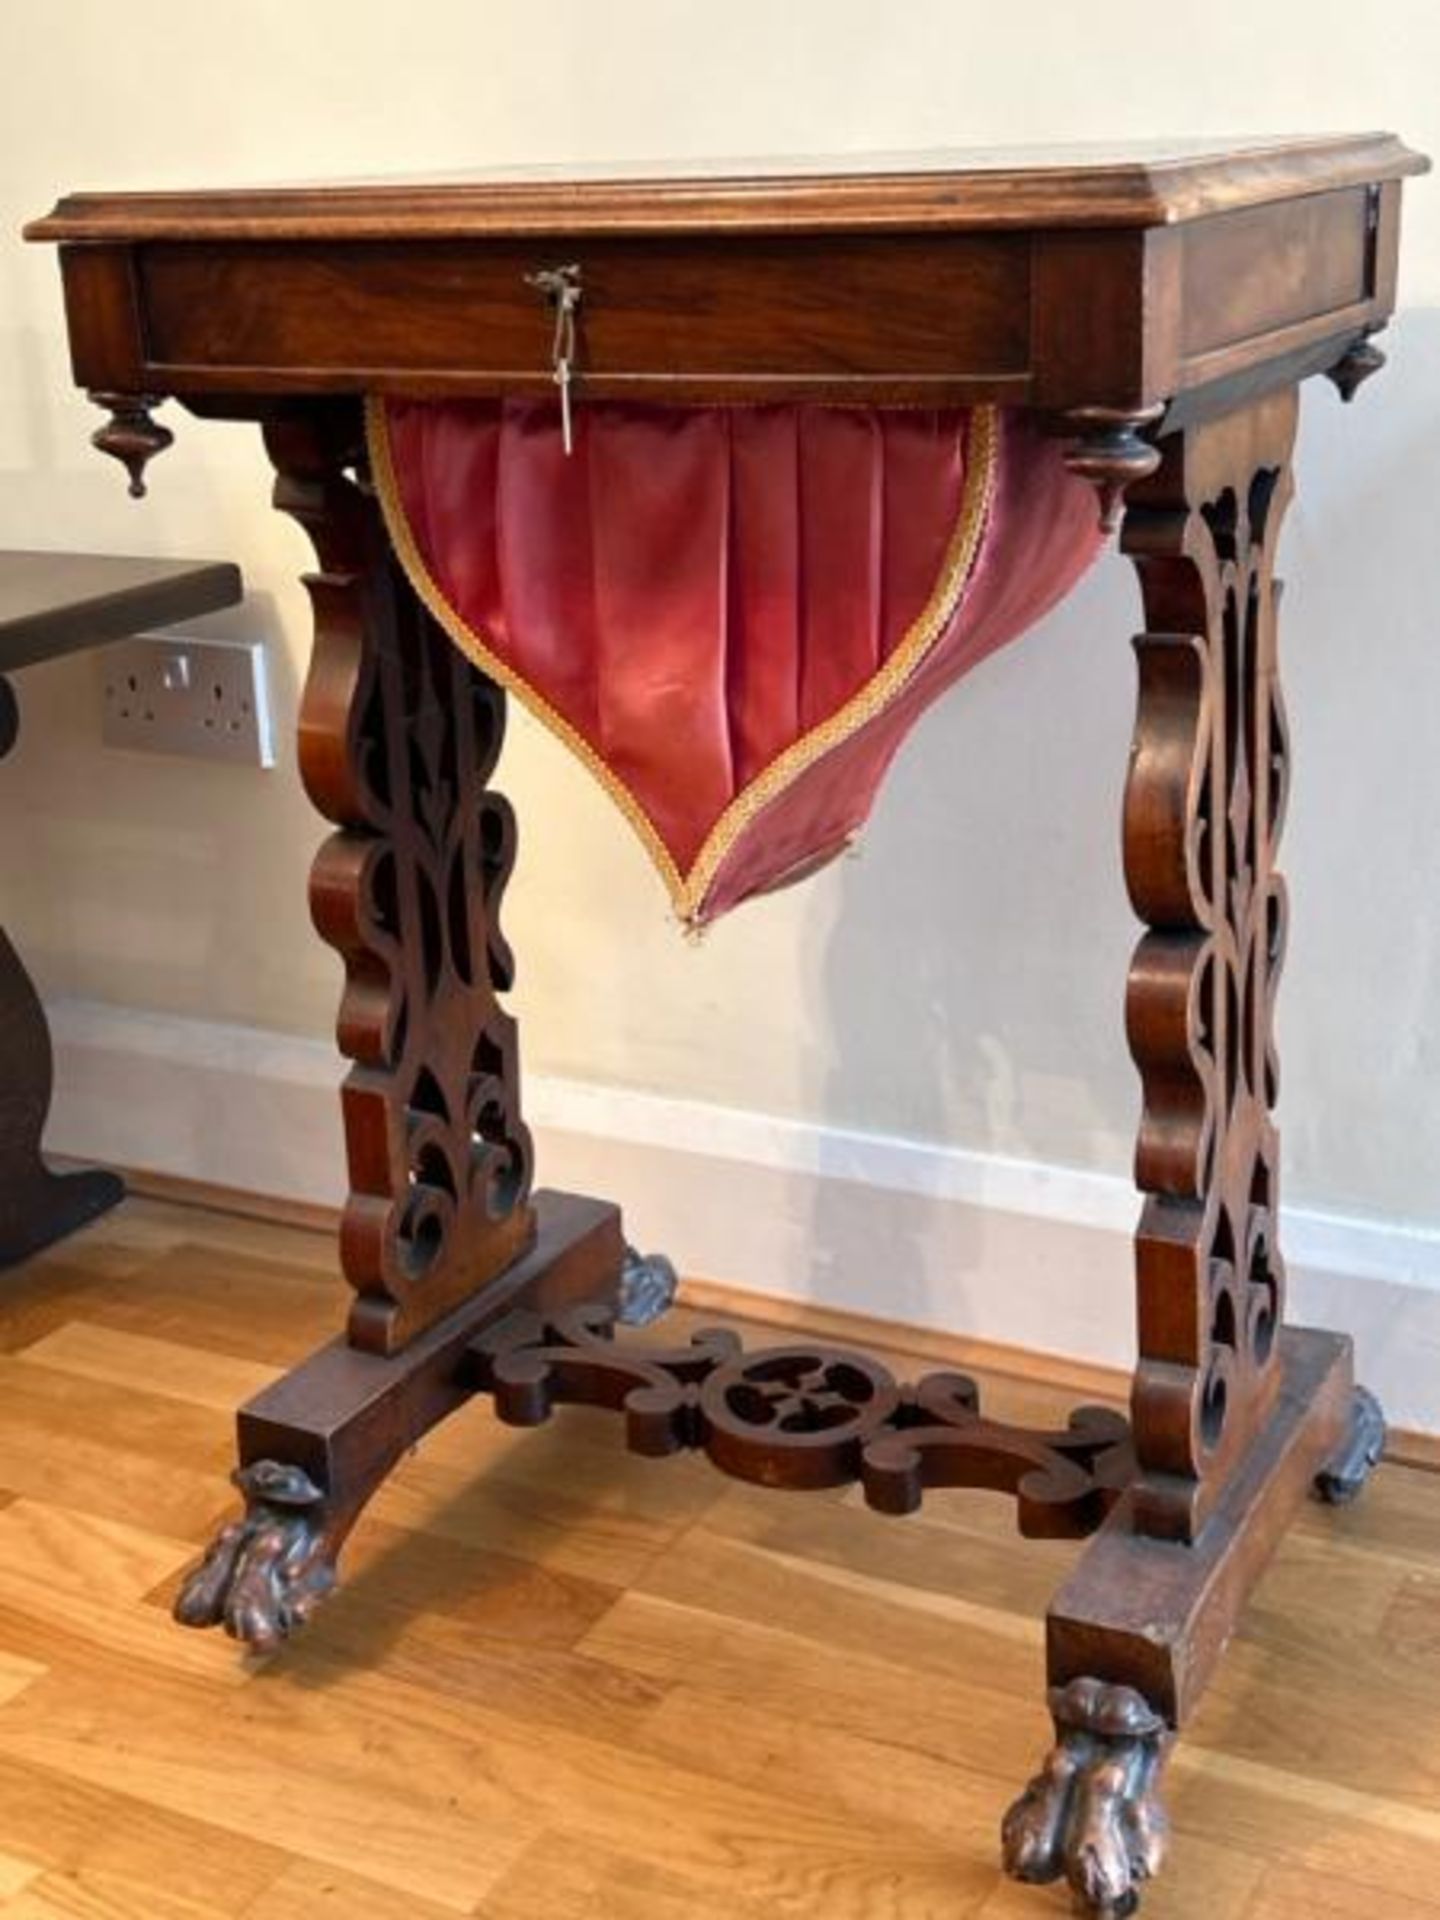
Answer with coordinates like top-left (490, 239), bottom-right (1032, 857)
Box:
top-left (46, 1000), bottom-right (1440, 1432)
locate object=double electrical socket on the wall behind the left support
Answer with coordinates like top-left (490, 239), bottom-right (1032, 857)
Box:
top-left (100, 634), bottom-right (275, 766)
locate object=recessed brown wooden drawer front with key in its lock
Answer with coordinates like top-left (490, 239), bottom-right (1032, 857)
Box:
top-left (134, 234), bottom-right (1031, 397)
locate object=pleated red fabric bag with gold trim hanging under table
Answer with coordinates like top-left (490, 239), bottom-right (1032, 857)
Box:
top-left (371, 399), bottom-right (1100, 922)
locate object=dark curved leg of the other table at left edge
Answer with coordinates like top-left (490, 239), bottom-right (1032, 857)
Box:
top-left (0, 678), bottom-right (125, 1267)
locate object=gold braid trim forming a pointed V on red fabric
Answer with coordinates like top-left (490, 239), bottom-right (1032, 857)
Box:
top-left (365, 394), bottom-right (1000, 925)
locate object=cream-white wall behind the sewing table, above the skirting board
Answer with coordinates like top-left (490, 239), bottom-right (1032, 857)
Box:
top-left (0, 0), bottom-right (1440, 1427)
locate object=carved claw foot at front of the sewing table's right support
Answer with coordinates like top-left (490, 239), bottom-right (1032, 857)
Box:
top-left (1002, 1680), bottom-right (1169, 1920)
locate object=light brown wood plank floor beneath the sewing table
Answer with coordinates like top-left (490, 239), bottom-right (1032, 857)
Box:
top-left (0, 1202), bottom-right (1440, 1920)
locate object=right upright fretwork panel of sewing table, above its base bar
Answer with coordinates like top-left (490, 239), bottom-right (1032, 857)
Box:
top-left (1123, 392), bottom-right (1296, 1540)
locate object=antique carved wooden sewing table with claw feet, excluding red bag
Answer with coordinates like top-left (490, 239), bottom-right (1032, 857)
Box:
top-left (29, 136), bottom-right (1425, 1914)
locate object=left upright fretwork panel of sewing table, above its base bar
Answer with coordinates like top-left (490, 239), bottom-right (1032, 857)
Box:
top-left (267, 407), bottom-right (534, 1352)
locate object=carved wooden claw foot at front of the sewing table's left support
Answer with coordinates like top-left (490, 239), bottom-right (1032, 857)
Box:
top-left (175, 1459), bottom-right (336, 1653)
